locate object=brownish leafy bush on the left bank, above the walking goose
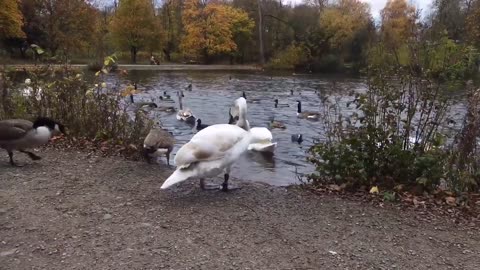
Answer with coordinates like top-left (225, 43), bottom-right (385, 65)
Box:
top-left (0, 57), bottom-right (151, 154)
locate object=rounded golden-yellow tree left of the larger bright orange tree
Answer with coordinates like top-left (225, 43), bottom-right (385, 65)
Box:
top-left (111, 0), bottom-right (162, 63)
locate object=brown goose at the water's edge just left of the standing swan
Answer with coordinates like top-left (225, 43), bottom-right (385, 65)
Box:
top-left (143, 124), bottom-right (175, 165)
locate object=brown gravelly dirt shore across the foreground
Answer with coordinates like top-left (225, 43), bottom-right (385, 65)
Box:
top-left (0, 149), bottom-right (480, 269)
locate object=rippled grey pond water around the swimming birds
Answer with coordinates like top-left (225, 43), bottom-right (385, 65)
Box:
top-left (108, 70), bottom-right (366, 185)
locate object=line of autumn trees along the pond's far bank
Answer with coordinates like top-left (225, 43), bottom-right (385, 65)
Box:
top-left (0, 0), bottom-right (480, 71)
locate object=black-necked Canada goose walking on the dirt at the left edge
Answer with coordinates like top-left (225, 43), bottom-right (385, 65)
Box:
top-left (0, 117), bottom-right (65, 166)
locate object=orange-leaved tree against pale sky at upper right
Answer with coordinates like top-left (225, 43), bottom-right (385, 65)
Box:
top-left (381, 0), bottom-right (417, 48)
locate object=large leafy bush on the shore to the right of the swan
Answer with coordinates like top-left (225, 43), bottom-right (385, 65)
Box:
top-left (309, 35), bottom-right (480, 191)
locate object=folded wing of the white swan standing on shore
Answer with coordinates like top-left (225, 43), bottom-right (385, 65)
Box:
top-left (175, 124), bottom-right (246, 167)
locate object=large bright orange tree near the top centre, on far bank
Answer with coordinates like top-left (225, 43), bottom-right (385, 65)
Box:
top-left (181, 0), bottom-right (254, 62)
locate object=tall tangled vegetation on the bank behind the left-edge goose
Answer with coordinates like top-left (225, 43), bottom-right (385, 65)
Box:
top-left (0, 57), bottom-right (153, 157)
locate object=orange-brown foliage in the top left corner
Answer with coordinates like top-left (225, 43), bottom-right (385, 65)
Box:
top-left (0, 0), bottom-right (25, 39)
